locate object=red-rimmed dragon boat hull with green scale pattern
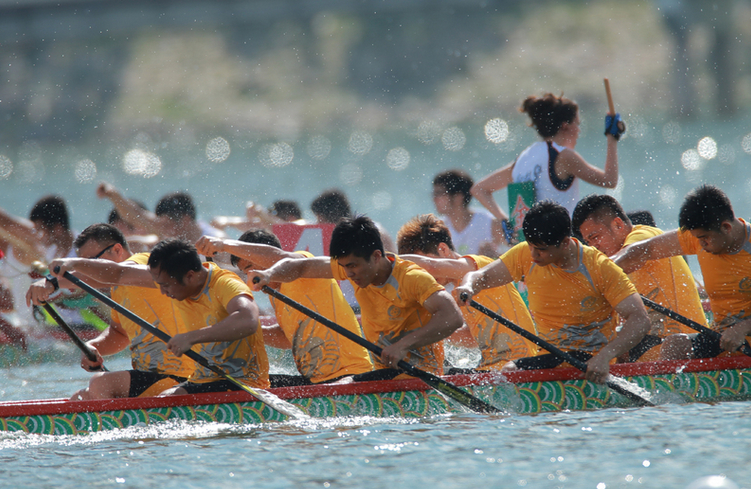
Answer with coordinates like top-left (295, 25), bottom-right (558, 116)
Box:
top-left (0, 356), bottom-right (751, 435)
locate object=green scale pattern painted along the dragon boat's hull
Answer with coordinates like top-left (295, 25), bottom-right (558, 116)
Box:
top-left (0, 369), bottom-right (751, 435)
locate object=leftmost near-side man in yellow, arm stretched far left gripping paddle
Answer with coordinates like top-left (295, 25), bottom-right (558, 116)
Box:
top-left (50, 239), bottom-right (269, 395)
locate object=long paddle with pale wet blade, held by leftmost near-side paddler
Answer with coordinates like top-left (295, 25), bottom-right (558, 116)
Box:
top-left (55, 270), bottom-right (309, 419)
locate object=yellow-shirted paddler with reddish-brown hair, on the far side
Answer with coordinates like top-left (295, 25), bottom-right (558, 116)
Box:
top-left (396, 214), bottom-right (537, 373)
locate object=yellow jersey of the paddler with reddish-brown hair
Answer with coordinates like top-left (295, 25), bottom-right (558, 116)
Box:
top-left (462, 255), bottom-right (537, 370)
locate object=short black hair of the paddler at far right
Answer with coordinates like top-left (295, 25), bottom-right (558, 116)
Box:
top-left (678, 185), bottom-right (735, 231)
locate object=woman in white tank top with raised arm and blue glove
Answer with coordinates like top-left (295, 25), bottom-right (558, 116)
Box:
top-left (471, 93), bottom-right (625, 221)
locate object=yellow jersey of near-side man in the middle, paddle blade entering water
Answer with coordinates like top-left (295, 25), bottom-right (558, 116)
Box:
top-left (331, 253), bottom-right (444, 375)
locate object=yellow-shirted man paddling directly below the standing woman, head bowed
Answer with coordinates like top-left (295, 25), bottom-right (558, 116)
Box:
top-left (454, 201), bottom-right (650, 383)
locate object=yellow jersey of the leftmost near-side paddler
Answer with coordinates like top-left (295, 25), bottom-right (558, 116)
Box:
top-left (173, 263), bottom-right (269, 389)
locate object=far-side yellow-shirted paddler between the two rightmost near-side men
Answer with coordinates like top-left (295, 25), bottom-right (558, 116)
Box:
top-left (571, 195), bottom-right (707, 362)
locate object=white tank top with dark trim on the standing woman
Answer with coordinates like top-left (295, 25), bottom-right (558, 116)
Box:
top-left (511, 141), bottom-right (579, 215)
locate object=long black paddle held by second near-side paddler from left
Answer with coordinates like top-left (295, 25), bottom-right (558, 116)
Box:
top-left (254, 277), bottom-right (502, 413)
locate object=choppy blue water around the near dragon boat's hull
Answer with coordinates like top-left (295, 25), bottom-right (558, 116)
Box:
top-left (0, 360), bottom-right (751, 489)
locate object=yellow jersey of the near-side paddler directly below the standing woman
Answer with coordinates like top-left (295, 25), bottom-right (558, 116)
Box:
top-left (501, 238), bottom-right (636, 354)
